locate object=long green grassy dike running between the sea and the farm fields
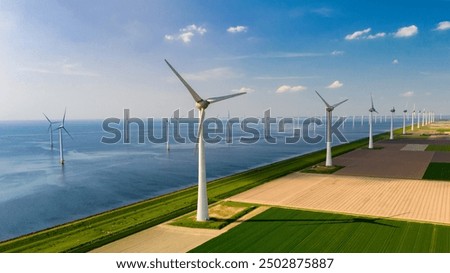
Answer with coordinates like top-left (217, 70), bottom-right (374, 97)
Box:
top-left (0, 129), bottom-right (401, 252)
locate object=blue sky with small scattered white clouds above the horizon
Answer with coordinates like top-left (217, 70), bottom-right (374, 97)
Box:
top-left (0, 0), bottom-right (450, 120)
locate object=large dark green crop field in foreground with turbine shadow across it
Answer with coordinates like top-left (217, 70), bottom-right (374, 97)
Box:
top-left (190, 208), bottom-right (450, 253)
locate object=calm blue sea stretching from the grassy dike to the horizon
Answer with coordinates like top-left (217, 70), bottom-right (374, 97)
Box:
top-left (0, 117), bottom-right (409, 240)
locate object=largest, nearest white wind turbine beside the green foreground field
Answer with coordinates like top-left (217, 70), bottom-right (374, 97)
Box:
top-left (164, 60), bottom-right (246, 221)
